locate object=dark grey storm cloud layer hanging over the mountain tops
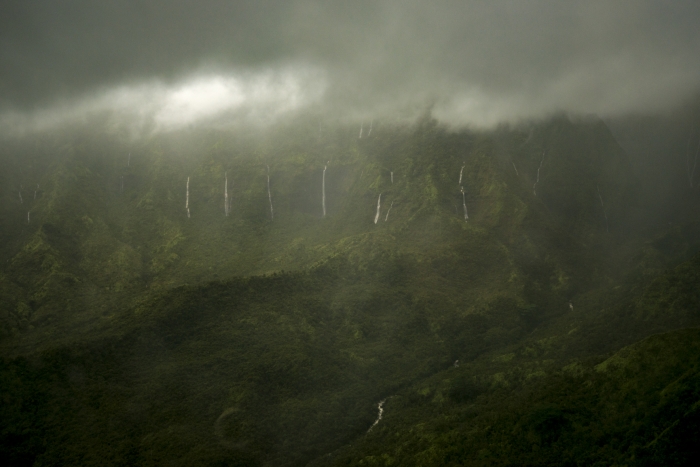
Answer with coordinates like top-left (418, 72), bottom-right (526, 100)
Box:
top-left (0, 0), bottom-right (700, 130)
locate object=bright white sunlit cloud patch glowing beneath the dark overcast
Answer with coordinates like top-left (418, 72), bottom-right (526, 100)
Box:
top-left (0, 69), bottom-right (326, 137)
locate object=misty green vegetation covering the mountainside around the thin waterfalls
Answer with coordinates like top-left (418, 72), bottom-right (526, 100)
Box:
top-left (0, 117), bottom-right (700, 466)
